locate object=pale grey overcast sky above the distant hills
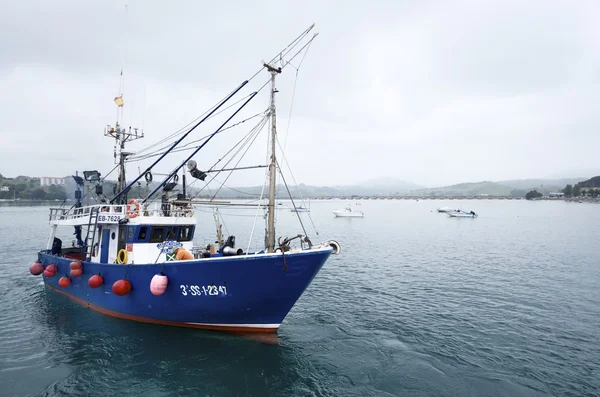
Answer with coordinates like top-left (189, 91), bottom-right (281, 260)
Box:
top-left (0, 0), bottom-right (600, 186)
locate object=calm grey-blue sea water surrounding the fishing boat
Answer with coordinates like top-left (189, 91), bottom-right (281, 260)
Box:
top-left (0, 200), bottom-right (600, 396)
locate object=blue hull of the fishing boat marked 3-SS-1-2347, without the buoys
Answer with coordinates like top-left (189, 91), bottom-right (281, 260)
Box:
top-left (39, 249), bottom-right (331, 332)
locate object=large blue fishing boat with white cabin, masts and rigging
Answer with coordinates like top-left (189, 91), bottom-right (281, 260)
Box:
top-left (30, 25), bottom-right (341, 332)
